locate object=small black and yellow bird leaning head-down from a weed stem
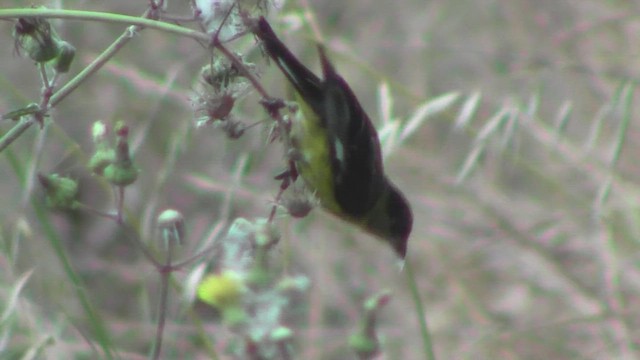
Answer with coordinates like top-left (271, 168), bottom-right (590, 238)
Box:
top-left (254, 17), bottom-right (413, 258)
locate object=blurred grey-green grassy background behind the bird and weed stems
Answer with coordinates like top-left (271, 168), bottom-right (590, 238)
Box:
top-left (0, 0), bottom-right (640, 359)
